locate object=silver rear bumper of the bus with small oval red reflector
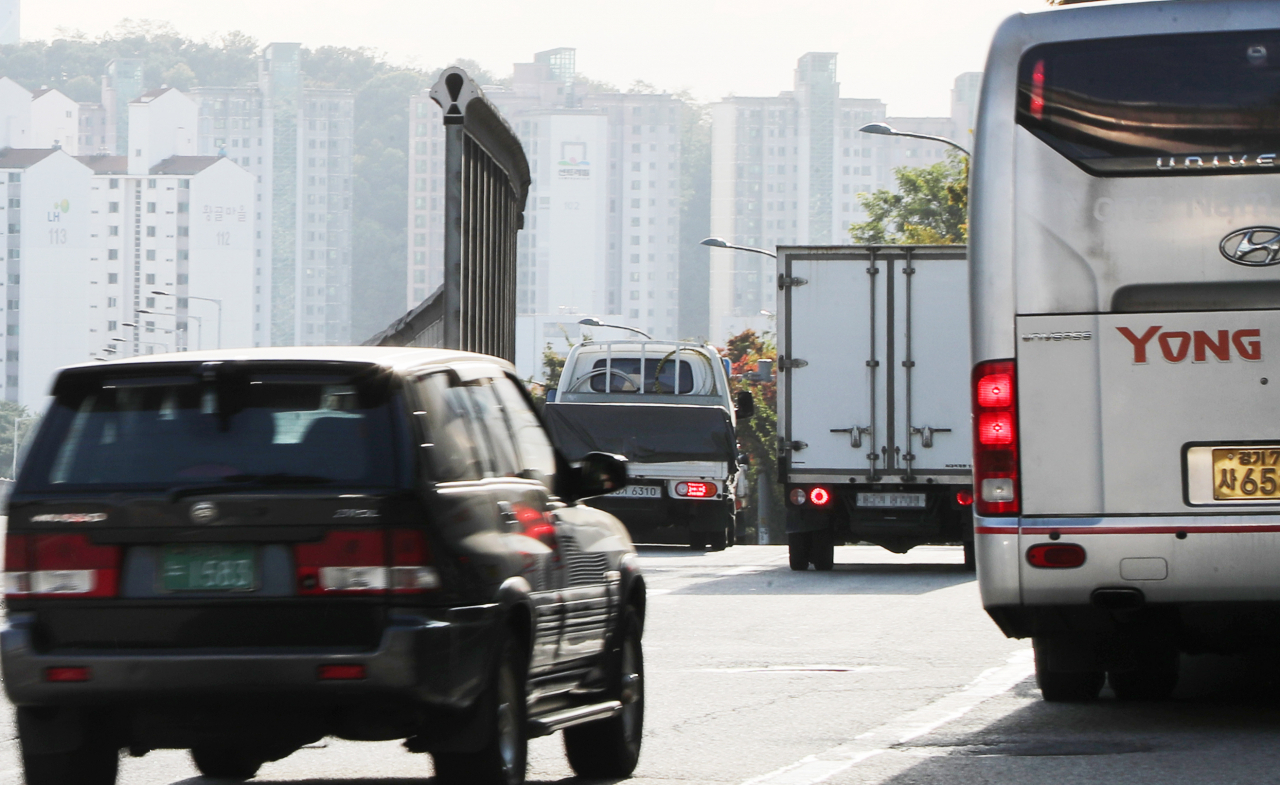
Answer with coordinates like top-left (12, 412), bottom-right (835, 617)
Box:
top-left (975, 515), bottom-right (1280, 617)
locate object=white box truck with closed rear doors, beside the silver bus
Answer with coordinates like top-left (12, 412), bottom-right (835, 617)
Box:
top-left (777, 246), bottom-right (973, 570)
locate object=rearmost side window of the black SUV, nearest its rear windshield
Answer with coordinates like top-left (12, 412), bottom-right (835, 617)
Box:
top-left (413, 373), bottom-right (485, 482)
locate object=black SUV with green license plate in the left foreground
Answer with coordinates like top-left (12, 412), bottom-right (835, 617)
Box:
top-left (0, 347), bottom-right (645, 785)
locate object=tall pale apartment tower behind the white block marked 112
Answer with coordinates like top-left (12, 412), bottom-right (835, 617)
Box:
top-left (192, 44), bottom-right (355, 346)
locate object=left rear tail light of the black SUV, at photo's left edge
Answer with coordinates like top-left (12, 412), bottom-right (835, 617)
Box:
top-left (4, 534), bottom-right (120, 597)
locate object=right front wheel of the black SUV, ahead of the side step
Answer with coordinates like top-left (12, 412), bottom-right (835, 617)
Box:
top-left (564, 607), bottom-right (644, 779)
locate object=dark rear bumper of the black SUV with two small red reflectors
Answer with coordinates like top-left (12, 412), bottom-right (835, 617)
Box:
top-left (0, 604), bottom-right (498, 708)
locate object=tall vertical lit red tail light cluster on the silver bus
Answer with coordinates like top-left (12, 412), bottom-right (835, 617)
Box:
top-left (973, 360), bottom-right (1021, 517)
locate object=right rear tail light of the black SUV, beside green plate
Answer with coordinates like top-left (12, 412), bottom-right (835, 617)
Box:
top-left (293, 529), bottom-right (440, 595)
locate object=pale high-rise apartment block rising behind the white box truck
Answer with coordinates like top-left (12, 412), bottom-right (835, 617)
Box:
top-left (708, 53), bottom-right (982, 339)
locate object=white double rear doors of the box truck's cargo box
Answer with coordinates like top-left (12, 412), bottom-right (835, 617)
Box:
top-left (778, 246), bottom-right (970, 482)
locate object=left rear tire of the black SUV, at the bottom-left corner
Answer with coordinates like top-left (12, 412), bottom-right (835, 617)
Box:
top-left (18, 707), bottom-right (120, 785)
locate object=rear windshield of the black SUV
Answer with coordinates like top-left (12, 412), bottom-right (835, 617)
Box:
top-left (23, 378), bottom-right (394, 489)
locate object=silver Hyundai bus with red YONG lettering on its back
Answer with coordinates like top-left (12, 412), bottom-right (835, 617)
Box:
top-left (970, 0), bottom-right (1280, 700)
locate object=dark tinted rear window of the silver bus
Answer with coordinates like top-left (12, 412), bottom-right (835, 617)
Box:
top-left (1018, 31), bottom-right (1280, 177)
